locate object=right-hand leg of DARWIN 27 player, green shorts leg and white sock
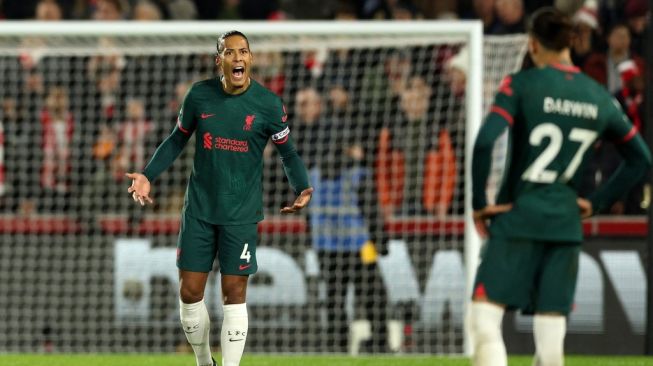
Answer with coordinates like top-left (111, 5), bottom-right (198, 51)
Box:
top-left (533, 243), bottom-right (580, 366)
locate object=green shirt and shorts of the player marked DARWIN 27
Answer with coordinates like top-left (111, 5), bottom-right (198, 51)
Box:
top-left (472, 65), bottom-right (651, 314)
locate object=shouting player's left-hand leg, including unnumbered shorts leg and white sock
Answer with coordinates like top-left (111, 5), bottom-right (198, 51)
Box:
top-left (177, 215), bottom-right (215, 366)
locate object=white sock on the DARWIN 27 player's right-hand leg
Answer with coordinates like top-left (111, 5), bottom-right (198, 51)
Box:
top-left (533, 314), bottom-right (567, 366)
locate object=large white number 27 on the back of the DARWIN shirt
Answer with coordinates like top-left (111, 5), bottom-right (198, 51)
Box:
top-left (522, 123), bottom-right (597, 183)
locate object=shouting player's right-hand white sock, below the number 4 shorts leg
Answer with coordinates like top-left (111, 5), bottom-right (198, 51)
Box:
top-left (220, 303), bottom-right (248, 366)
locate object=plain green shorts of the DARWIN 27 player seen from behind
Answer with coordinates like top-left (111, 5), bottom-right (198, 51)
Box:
top-left (474, 235), bottom-right (581, 315)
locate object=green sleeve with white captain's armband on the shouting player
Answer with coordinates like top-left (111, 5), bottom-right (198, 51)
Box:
top-left (267, 99), bottom-right (310, 194)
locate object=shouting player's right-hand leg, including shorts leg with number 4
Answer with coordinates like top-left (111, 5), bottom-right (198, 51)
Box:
top-left (218, 224), bottom-right (258, 366)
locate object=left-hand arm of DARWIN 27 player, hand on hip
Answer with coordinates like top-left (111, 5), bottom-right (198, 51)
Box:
top-left (472, 76), bottom-right (518, 237)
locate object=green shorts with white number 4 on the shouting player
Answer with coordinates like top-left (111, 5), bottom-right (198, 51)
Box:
top-left (177, 213), bottom-right (258, 275)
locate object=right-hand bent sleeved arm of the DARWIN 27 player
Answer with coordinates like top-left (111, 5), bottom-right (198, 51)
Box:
top-left (589, 106), bottom-right (651, 214)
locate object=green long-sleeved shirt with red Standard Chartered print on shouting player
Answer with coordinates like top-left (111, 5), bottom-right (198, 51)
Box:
top-left (143, 78), bottom-right (309, 225)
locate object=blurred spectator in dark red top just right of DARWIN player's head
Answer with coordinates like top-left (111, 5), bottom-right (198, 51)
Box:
top-left (583, 23), bottom-right (644, 94)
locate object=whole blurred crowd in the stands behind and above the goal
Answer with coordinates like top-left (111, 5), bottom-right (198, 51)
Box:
top-left (0, 0), bottom-right (650, 223)
